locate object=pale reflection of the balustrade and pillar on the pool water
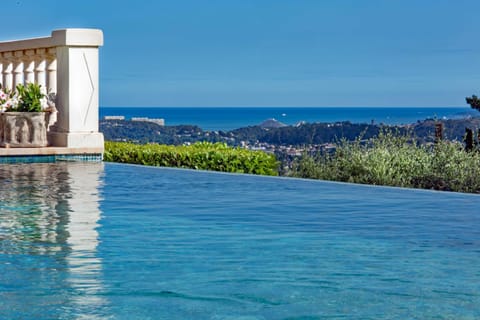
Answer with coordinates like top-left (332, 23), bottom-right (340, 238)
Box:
top-left (0, 162), bottom-right (106, 318)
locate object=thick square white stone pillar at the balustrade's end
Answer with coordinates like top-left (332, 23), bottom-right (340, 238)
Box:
top-left (49, 29), bottom-right (103, 150)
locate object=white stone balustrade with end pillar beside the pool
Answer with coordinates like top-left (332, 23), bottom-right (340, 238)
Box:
top-left (0, 29), bottom-right (103, 150)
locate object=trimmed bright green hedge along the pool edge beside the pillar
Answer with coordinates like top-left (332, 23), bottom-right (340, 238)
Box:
top-left (104, 141), bottom-right (278, 175)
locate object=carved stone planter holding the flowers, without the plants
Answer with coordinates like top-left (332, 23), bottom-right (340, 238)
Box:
top-left (0, 112), bottom-right (49, 148)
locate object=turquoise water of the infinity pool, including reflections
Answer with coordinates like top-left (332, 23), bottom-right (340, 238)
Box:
top-left (0, 163), bottom-right (480, 319)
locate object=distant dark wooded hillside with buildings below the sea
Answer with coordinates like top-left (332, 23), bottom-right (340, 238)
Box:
top-left (100, 118), bottom-right (480, 146)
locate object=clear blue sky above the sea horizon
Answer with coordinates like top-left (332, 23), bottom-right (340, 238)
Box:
top-left (0, 0), bottom-right (480, 107)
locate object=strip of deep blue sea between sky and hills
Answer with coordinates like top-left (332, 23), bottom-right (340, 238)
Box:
top-left (100, 107), bottom-right (480, 131)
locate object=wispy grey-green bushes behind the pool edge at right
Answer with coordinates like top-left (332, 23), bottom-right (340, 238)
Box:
top-left (290, 131), bottom-right (480, 193)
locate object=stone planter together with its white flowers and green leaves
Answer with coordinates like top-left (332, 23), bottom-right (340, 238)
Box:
top-left (0, 83), bottom-right (56, 148)
